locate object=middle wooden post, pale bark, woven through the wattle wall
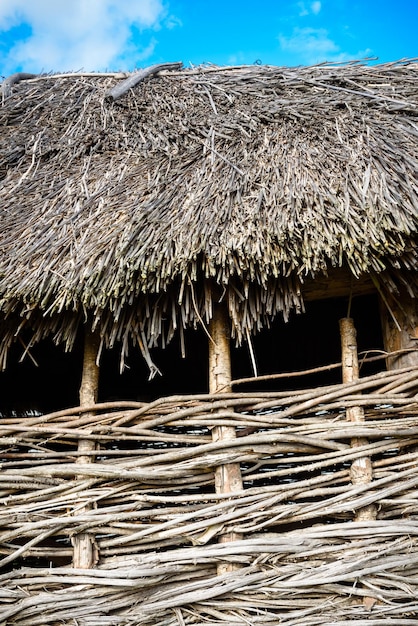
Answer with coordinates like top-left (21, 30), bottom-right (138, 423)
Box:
top-left (209, 304), bottom-right (243, 574)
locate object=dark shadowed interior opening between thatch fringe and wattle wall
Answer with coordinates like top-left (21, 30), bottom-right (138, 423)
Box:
top-left (0, 295), bottom-right (384, 415)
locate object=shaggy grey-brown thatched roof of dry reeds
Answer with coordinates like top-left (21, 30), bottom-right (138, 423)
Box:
top-left (0, 62), bottom-right (418, 364)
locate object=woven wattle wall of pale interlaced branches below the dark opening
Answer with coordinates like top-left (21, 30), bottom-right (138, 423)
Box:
top-left (0, 368), bottom-right (418, 626)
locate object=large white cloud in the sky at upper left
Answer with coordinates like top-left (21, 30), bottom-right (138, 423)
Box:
top-left (0, 0), bottom-right (170, 72)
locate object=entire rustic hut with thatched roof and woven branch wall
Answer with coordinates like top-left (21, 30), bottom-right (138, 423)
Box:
top-left (0, 60), bottom-right (418, 626)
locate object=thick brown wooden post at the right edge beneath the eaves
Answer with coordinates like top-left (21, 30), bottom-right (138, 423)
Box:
top-left (380, 293), bottom-right (418, 370)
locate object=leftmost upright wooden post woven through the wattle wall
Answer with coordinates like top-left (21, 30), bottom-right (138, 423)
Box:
top-left (73, 328), bottom-right (100, 569)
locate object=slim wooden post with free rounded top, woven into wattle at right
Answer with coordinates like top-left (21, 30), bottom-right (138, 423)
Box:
top-left (340, 317), bottom-right (376, 522)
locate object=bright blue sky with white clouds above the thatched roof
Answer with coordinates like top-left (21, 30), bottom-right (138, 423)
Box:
top-left (0, 0), bottom-right (418, 76)
